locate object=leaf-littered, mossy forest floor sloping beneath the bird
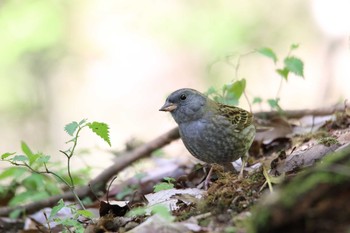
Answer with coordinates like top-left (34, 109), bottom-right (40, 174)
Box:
top-left (0, 106), bottom-right (350, 233)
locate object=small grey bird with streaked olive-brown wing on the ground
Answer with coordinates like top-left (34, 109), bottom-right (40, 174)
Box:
top-left (159, 88), bottom-right (256, 185)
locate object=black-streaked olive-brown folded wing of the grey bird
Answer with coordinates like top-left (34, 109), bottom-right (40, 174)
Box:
top-left (218, 104), bottom-right (253, 131)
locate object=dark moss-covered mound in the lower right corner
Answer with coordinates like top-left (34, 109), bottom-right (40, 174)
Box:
top-left (247, 146), bottom-right (350, 233)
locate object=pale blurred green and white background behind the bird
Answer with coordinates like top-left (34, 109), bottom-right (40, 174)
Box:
top-left (0, 0), bottom-right (350, 171)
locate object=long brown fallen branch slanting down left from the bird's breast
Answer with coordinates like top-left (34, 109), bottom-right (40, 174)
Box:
top-left (0, 128), bottom-right (180, 216)
